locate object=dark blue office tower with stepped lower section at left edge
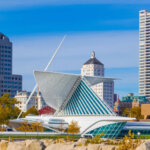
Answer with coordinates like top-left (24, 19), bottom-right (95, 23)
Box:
top-left (0, 33), bottom-right (22, 97)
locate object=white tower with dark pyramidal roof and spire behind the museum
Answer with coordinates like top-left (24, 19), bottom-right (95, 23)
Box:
top-left (81, 52), bottom-right (114, 109)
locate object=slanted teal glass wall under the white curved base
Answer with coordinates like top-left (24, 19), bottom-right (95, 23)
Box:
top-left (86, 122), bottom-right (126, 139)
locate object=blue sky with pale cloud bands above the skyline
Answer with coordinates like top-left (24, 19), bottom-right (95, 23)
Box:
top-left (0, 0), bottom-right (150, 97)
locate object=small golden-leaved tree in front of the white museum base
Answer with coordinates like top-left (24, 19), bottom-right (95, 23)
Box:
top-left (67, 120), bottom-right (80, 134)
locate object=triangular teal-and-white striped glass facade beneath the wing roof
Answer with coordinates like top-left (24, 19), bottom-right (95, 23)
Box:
top-left (61, 80), bottom-right (115, 115)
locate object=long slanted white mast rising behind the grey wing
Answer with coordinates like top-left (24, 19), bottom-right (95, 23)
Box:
top-left (17, 35), bottom-right (66, 119)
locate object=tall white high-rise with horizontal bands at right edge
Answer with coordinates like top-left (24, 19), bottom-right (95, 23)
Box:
top-left (139, 10), bottom-right (150, 99)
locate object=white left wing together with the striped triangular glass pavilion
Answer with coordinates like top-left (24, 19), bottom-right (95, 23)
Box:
top-left (34, 71), bottom-right (115, 115)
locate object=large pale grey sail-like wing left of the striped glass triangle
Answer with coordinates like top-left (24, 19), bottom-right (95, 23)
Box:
top-left (34, 71), bottom-right (80, 110)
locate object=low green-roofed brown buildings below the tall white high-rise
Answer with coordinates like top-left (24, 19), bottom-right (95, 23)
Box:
top-left (114, 93), bottom-right (150, 113)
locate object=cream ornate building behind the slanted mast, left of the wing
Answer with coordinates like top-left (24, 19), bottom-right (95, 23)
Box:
top-left (15, 91), bottom-right (47, 112)
